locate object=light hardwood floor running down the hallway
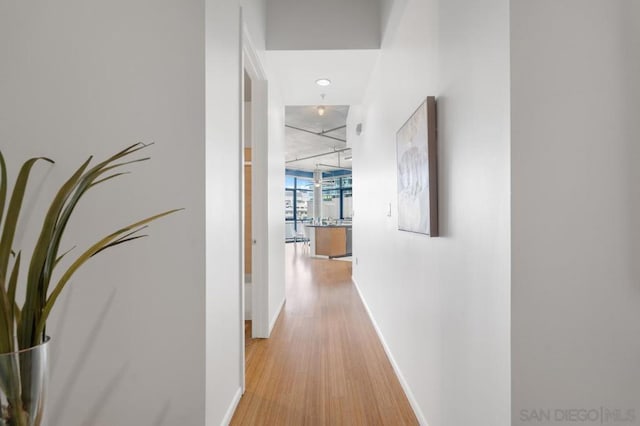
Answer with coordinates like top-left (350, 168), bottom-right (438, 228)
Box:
top-left (231, 244), bottom-right (418, 425)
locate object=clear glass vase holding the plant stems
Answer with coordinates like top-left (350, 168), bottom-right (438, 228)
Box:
top-left (0, 338), bottom-right (49, 426)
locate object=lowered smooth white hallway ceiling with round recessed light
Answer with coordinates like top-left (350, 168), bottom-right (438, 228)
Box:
top-left (266, 49), bottom-right (379, 105)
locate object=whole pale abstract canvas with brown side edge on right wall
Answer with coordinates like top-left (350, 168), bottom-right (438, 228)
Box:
top-left (396, 96), bottom-right (438, 237)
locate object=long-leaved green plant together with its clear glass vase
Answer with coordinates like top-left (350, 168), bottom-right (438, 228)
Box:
top-left (0, 143), bottom-right (177, 426)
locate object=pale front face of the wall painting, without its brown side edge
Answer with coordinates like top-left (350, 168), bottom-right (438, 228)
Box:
top-left (397, 102), bottom-right (431, 234)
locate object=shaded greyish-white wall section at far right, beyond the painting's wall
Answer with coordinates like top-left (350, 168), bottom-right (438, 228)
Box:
top-left (511, 0), bottom-right (640, 425)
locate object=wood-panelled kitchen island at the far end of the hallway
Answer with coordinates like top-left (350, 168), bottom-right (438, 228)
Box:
top-left (305, 224), bottom-right (352, 258)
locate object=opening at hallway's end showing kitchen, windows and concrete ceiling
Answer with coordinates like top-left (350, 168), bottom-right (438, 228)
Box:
top-left (285, 105), bottom-right (353, 261)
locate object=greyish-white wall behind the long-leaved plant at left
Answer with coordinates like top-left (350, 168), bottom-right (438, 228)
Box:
top-left (0, 0), bottom-right (205, 426)
